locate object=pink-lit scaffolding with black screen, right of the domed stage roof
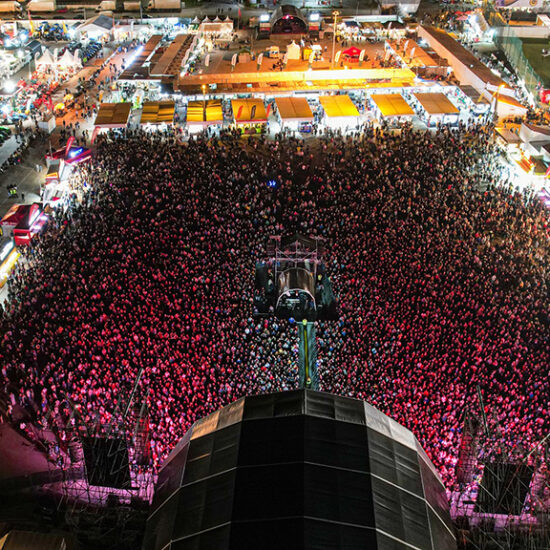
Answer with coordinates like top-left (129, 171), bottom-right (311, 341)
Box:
top-left (451, 404), bottom-right (550, 550)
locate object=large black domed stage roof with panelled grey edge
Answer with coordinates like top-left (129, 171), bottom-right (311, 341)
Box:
top-left (143, 389), bottom-right (456, 550)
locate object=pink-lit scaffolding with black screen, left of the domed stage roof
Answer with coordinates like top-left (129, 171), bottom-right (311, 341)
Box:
top-left (39, 382), bottom-right (155, 550)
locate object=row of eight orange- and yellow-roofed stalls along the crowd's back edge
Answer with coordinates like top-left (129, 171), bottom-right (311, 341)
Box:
top-left (95, 92), bottom-right (474, 133)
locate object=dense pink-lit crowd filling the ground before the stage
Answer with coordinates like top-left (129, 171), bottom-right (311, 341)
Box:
top-left (0, 128), bottom-right (550, 487)
